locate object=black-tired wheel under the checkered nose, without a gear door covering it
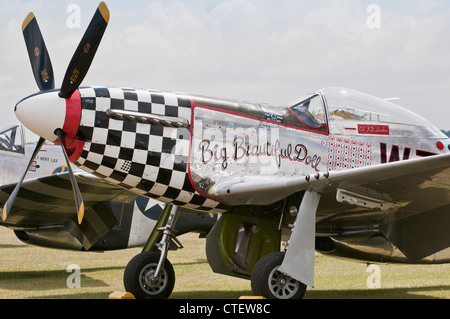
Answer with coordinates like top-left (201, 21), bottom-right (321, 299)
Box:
top-left (123, 251), bottom-right (175, 299)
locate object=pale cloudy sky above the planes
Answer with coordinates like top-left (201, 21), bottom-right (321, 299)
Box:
top-left (0, 0), bottom-right (450, 142)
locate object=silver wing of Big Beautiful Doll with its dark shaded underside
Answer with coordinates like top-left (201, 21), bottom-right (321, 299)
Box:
top-left (208, 154), bottom-right (450, 261)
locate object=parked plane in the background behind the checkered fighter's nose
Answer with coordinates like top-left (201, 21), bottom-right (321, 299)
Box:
top-left (0, 125), bottom-right (216, 251)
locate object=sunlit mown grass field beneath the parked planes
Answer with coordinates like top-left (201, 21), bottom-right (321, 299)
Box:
top-left (0, 227), bottom-right (450, 299)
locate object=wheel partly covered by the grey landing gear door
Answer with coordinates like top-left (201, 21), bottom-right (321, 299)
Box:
top-left (251, 252), bottom-right (306, 299)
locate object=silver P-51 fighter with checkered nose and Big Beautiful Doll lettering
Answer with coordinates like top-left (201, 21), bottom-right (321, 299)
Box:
top-left (3, 3), bottom-right (450, 298)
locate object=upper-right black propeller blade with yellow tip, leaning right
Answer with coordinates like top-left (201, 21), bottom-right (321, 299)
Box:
top-left (59, 2), bottom-right (109, 99)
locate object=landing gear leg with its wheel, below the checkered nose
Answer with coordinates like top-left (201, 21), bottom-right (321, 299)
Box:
top-left (123, 204), bottom-right (180, 299)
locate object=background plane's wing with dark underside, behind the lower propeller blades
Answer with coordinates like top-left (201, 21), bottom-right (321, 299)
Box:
top-left (0, 171), bottom-right (136, 249)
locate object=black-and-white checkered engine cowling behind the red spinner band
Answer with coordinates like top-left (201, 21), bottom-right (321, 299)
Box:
top-left (76, 87), bottom-right (227, 212)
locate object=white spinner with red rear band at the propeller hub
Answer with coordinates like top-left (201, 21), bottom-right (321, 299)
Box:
top-left (14, 91), bottom-right (81, 142)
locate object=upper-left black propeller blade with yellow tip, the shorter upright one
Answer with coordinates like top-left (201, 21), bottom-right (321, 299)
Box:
top-left (22, 12), bottom-right (55, 91)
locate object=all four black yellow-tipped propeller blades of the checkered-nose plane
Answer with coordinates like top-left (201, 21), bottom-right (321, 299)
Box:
top-left (2, 2), bottom-right (109, 223)
